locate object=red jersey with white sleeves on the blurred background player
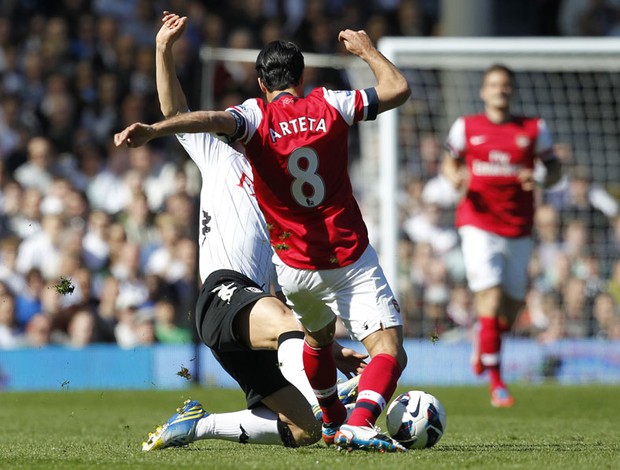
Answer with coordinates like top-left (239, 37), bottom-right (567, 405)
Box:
top-left (447, 114), bottom-right (554, 238)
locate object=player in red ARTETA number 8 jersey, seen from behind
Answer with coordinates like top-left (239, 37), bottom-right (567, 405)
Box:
top-left (115, 26), bottom-right (410, 451)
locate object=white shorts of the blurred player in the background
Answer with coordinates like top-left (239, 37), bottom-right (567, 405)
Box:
top-left (459, 225), bottom-right (532, 300)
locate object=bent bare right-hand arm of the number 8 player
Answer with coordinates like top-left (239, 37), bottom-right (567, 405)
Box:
top-left (338, 29), bottom-right (411, 113)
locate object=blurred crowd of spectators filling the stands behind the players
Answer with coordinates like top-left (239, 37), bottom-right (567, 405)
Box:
top-left (0, 0), bottom-right (620, 348)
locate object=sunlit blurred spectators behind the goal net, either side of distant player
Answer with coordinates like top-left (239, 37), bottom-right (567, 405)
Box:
top-left (399, 139), bottom-right (620, 342)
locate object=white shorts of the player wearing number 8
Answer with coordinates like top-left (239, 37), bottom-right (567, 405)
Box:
top-left (273, 245), bottom-right (402, 341)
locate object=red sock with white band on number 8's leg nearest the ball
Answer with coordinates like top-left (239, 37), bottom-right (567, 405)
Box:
top-left (347, 354), bottom-right (402, 426)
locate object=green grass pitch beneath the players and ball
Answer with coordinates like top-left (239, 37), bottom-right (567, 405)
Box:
top-left (0, 384), bottom-right (620, 470)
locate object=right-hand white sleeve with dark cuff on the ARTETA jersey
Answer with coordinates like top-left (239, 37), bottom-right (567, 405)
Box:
top-left (323, 88), bottom-right (379, 126)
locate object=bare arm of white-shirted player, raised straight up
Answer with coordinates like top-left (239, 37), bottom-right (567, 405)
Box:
top-left (155, 11), bottom-right (188, 117)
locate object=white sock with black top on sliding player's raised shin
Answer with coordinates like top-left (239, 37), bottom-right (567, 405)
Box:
top-left (278, 331), bottom-right (319, 408)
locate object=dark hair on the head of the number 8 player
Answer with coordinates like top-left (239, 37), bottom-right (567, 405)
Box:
top-left (256, 41), bottom-right (304, 92)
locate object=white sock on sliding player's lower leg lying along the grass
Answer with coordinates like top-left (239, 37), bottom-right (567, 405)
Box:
top-left (196, 407), bottom-right (282, 445)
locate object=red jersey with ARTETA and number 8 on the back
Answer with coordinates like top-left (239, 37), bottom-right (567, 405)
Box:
top-left (228, 88), bottom-right (378, 270)
